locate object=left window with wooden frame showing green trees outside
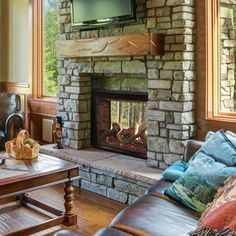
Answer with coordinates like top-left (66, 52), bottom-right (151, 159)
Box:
top-left (31, 0), bottom-right (59, 98)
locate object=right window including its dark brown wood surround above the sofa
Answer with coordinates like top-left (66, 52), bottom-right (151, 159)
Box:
top-left (195, 0), bottom-right (236, 139)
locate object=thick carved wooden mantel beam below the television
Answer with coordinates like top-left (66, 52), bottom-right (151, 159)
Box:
top-left (56, 33), bottom-right (164, 58)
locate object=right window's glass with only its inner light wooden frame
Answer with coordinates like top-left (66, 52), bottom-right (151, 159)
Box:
top-left (211, 0), bottom-right (236, 119)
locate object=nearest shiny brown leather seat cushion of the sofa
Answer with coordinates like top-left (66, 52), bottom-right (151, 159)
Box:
top-left (111, 195), bottom-right (199, 236)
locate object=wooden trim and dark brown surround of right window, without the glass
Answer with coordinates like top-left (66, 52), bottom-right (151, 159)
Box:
top-left (195, 0), bottom-right (236, 139)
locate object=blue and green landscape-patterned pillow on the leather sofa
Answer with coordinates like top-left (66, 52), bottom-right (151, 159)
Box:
top-left (166, 151), bottom-right (236, 212)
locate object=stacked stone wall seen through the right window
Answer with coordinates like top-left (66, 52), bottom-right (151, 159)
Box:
top-left (220, 0), bottom-right (236, 112)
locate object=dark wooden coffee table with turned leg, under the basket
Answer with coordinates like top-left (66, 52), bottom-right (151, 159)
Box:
top-left (0, 153), bottom-right (79, 235)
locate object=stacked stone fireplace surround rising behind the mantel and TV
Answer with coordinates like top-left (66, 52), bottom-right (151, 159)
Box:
top-left (58, 0), bottom-right (195, 168)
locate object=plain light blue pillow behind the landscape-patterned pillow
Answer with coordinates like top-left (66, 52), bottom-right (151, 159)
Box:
top-left (192, 130), bottom-right (236, 166)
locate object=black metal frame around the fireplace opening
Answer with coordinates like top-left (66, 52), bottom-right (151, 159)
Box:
top-left (91, 89), bottom-right (148, 159)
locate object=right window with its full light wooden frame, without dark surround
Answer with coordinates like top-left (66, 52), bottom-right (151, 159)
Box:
top-left (198, 0), bottom-right (236, 120)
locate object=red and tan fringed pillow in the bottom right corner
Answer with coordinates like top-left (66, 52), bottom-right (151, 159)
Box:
top-left (190, 176), bottom-right (236, 236)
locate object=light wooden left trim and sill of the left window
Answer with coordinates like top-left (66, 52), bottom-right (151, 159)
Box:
top-left (31, 0), bottom-right (57, 102)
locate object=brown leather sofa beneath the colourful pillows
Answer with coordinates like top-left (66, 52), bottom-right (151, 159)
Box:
top-left (56, 140), bottom-right (203, 236)
